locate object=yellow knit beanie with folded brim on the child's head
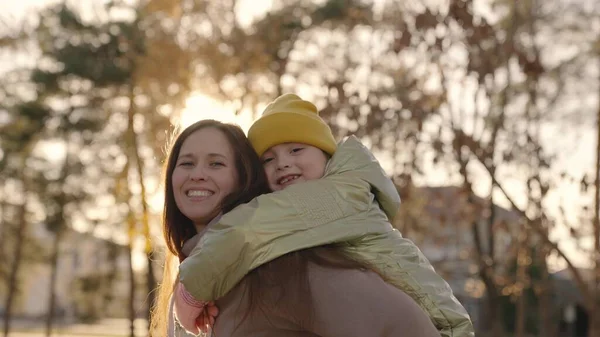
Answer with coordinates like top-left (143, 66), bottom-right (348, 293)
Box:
top-left (248, 94), bottom-right (337, 156)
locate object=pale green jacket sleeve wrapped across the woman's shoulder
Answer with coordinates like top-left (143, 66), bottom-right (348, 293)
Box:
top-left (179, 176), bottom-right (389, 301)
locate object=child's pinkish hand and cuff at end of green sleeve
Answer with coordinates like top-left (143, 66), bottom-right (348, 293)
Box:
top-left (173, 282), bottom-right (209, 335)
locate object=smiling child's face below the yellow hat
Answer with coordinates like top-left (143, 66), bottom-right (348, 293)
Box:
top-left (261, 143), bottom-right (328, 191)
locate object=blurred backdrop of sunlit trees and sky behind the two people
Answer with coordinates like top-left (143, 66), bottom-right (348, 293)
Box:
top-left (0, 0), bottom-right (600, 337)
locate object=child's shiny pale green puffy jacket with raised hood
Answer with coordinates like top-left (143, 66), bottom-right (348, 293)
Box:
top-left (179, 137), bottom-right (474, 337)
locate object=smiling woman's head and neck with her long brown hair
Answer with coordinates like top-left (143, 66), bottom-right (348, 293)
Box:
top-left (151, 120), bottom-right (268, 337)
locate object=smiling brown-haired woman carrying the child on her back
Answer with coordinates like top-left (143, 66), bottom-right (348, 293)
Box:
top-left (153, 121), bottom-right (439, 337)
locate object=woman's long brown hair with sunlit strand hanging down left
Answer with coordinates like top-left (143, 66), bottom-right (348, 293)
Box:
top-left (150, 120), bottom-right (268, 337)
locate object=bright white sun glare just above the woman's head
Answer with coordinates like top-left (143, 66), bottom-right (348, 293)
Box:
top-left (179, 94), bottom-right (253, 132)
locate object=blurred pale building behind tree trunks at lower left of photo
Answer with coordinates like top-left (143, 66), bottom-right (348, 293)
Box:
top-left (0, 225), bottom-right (146, 322)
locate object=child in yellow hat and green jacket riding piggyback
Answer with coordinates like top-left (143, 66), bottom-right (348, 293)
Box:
top-left (175, 94), bottom-right (474, 337)
